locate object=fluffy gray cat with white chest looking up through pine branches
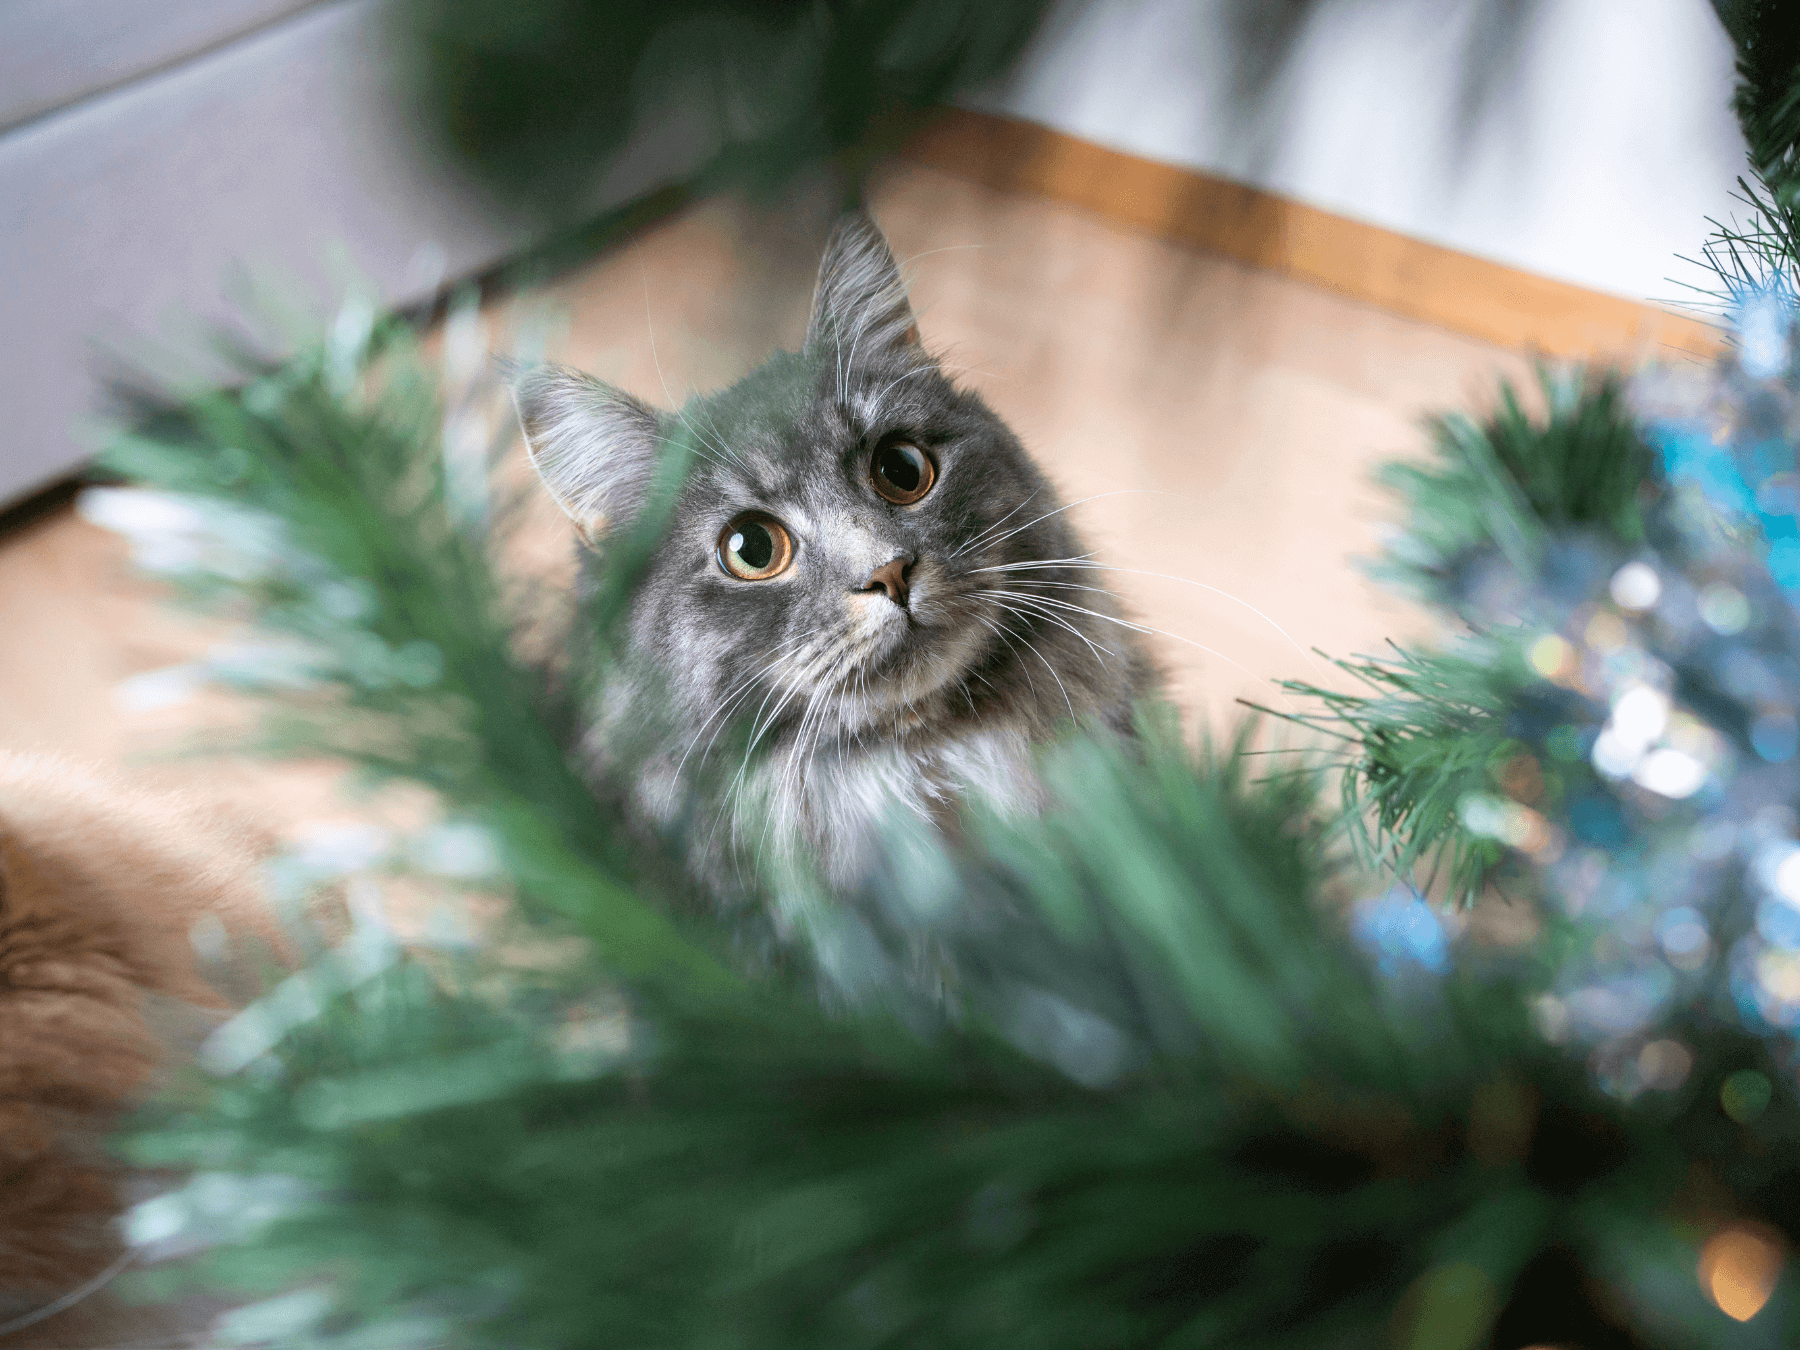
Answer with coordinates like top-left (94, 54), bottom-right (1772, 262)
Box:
top-left (515, 212), bottom-right (1157, 903)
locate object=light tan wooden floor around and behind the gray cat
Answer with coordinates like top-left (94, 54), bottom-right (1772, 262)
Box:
top-left (0, 164), bottom-right (1526, 817)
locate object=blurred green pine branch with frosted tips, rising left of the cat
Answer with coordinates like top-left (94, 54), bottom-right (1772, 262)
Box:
top-left (103, 320), bottom-right (734, 992)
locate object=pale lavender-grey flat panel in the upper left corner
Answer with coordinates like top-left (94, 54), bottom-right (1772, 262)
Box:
top-left (0, 0), bottom-right (713, 508)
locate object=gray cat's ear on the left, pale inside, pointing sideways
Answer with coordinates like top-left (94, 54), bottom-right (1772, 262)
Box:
top-left (511, 364), bottom-right (662, 544)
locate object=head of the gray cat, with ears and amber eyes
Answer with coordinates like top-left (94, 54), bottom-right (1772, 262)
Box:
top-left (515, 214), bottom-right (1073, 745)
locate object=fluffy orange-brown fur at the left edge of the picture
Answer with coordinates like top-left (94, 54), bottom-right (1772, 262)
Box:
top-left (0, 752), bottom-right (266, 1325)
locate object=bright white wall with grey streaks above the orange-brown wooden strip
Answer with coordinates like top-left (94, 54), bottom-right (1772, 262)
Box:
top-left (967, 0), bottom-right (1744, 299)
